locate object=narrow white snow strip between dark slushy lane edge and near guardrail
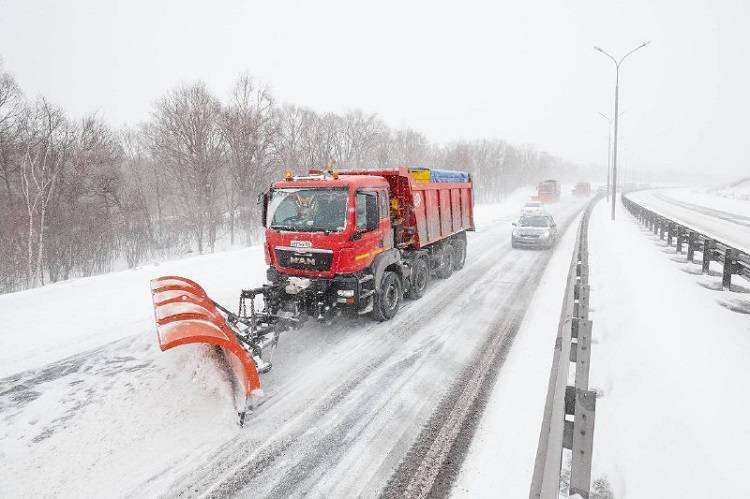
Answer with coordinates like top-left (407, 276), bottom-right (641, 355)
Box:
top-left (452, 206), bottom-right (580, 498)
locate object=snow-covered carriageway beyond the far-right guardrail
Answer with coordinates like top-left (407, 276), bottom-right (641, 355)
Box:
top-left (627, 188), bottom-right (750, 253)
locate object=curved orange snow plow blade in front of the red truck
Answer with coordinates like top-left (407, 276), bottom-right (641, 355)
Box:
top-left (151, 276), bottom-right (262, 410)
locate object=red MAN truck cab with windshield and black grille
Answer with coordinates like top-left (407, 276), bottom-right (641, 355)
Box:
top-left (264, 175), bottom-right (394, 279)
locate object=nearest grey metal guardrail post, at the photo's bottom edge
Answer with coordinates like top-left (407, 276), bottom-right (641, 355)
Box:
top-left (569, 388), bottom-right (596, 499)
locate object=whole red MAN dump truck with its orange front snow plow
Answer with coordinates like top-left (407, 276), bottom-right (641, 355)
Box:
top-left (151, 168), bottom-right (474, 424)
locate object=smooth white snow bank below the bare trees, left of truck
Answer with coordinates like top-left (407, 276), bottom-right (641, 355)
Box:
top-left (0, 246), bottom-right (266, 378)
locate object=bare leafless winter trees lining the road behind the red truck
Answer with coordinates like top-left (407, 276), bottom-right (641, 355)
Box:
top-left (0, 66), bottom-right (584, 292)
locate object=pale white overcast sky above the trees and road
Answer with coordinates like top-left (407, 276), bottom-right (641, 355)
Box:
top-left (0, 0), bottom-right (750, 177)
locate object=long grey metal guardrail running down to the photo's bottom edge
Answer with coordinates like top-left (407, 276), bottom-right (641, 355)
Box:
top-left (529, 195), bottom-right (601, 499)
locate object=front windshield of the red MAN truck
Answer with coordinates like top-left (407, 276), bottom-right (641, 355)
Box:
top-left (268, 188), bottom-right (349, 232)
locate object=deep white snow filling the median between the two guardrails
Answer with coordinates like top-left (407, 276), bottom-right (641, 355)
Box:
top-left (589, 200), bottom-right (750, 499)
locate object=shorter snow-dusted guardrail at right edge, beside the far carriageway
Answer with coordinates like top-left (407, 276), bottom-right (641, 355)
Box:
top-left (622, 194), bottom-right (750, 289)
